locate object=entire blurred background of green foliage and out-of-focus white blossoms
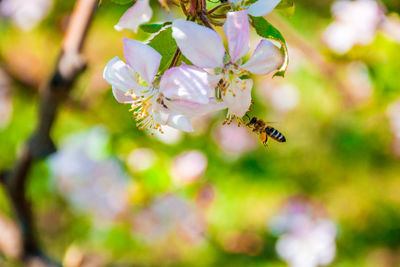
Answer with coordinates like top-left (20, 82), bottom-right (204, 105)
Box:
top-left (0, 0), bottom-right (400, 267)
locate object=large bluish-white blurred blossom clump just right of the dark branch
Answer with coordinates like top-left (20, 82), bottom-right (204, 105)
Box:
top-left (49, 127), bottom-right (128, 220)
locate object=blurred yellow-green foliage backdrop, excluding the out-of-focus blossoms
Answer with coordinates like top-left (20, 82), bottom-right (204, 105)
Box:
top-left (0, 0), bottom-right (400, 267)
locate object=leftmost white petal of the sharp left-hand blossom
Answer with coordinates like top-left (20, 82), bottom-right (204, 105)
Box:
top-left (103, 57), bottom-right (145, 103)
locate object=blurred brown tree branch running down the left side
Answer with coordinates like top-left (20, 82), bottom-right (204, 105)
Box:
top-left (1, 0), bottom-right (97, 265)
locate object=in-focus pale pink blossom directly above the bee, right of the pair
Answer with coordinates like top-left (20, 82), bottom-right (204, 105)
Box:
top-left (172, 11), bottom-right (283, 117)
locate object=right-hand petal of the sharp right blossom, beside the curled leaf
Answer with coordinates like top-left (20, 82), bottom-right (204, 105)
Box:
top-left (242, 39), bottom-right (284, 75)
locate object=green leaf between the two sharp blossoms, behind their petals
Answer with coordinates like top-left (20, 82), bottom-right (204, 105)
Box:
top-left (147, 26), bottom-right (178, 72)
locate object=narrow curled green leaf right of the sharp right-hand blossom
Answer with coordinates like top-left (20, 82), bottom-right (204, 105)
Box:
top-left (251, 16), bottom-right (289, 77)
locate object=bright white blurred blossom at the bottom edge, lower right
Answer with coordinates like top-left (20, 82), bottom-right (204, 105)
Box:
top-left (270, 198), bottom-right (336, 267)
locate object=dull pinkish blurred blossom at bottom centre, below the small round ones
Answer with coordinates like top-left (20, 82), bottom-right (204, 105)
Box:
top-left (133, 194), bottom-right (206, 243)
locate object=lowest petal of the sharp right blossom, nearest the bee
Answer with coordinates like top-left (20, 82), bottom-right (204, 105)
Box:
top-left (222, 78), bottom-right (253, 118)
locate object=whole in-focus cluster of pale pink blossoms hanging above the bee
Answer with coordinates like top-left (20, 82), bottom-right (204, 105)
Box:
top-left (104, 0), bottom-right (285, 133)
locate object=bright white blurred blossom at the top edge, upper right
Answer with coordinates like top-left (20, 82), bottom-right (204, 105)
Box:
top-left (322, 0), bottom-right (384, 54)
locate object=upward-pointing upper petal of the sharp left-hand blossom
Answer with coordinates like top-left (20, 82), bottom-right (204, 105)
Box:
top-left (123, 38), bottom-right (161, 85)
